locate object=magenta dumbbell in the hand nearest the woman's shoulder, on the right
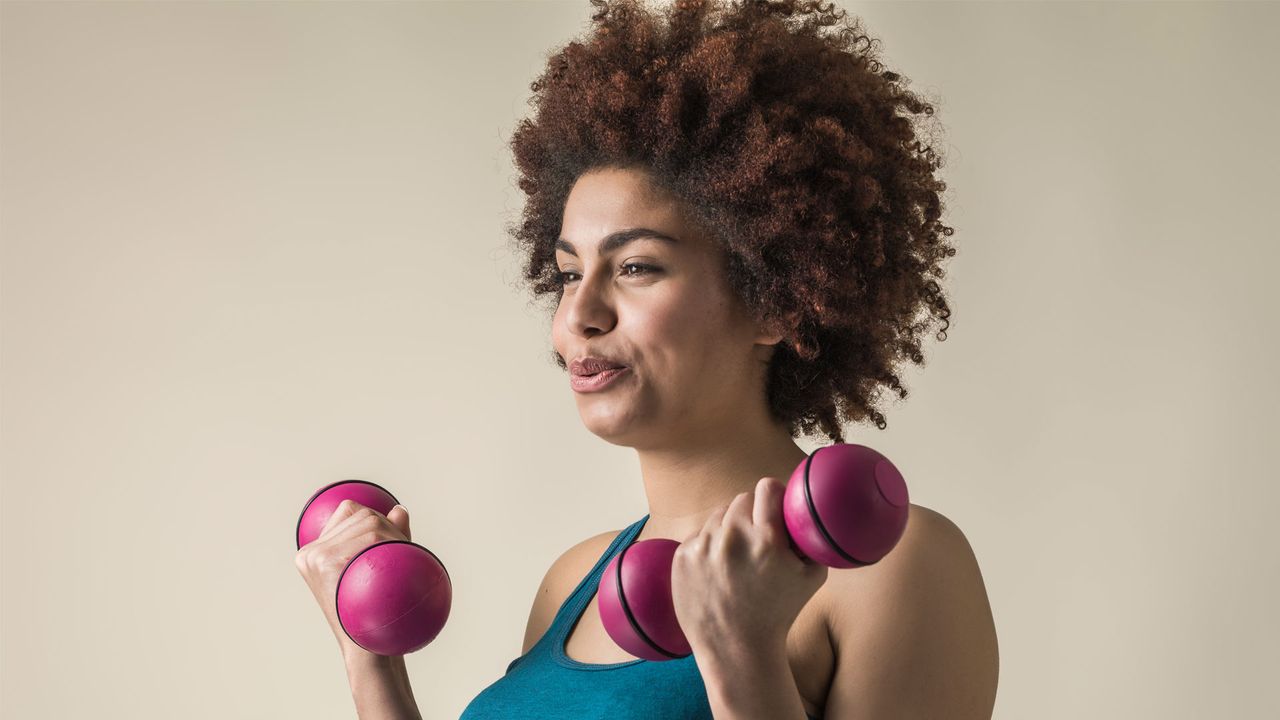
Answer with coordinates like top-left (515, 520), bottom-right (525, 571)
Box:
top-left (596, 443), bottom-right (910, 661)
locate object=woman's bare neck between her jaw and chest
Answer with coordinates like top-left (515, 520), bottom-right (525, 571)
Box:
top-left (636, 423), bottom-right (809, 542)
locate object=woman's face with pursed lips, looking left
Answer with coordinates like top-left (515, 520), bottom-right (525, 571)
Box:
top-left (552, 169), bottom-right (780, 448)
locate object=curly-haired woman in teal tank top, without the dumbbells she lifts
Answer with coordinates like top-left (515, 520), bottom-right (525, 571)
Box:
top-left (300, 0), bottom-right (998, 720)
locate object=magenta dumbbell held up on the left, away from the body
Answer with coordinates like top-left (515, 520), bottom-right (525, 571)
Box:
top-left (297, 480), bottom-right (453, 655)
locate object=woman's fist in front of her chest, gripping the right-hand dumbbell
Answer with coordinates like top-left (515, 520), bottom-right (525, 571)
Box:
top-left (671, 478), bottom-right (827, 657)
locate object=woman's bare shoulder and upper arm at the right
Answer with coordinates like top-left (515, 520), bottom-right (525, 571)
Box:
top-left (819, 505), bottom-right (1000, 719)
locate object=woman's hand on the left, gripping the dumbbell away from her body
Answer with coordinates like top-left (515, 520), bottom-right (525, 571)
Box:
top-left (294, 500), bottom-right (412, 664)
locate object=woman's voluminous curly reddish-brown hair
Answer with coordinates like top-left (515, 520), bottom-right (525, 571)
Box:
top-left (507, 0), bottom-right (955, 442)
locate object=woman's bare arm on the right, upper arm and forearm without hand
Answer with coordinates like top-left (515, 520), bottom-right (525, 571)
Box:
top-left (698, 505), bottom-right (1000, 720)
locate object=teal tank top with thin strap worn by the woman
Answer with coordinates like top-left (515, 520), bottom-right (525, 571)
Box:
top-left (458, 515), bottom-right (818, 720)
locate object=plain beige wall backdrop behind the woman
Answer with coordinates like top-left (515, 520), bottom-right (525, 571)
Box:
top-left (0, 0), bottom-right (1280, 720)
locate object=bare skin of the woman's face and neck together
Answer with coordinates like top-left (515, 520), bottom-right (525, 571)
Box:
top-left (552, 163), bottom-right (808, 539)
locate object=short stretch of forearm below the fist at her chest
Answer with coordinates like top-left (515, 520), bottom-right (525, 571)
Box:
top-left (698, 644), bottom-right (808, 720)
